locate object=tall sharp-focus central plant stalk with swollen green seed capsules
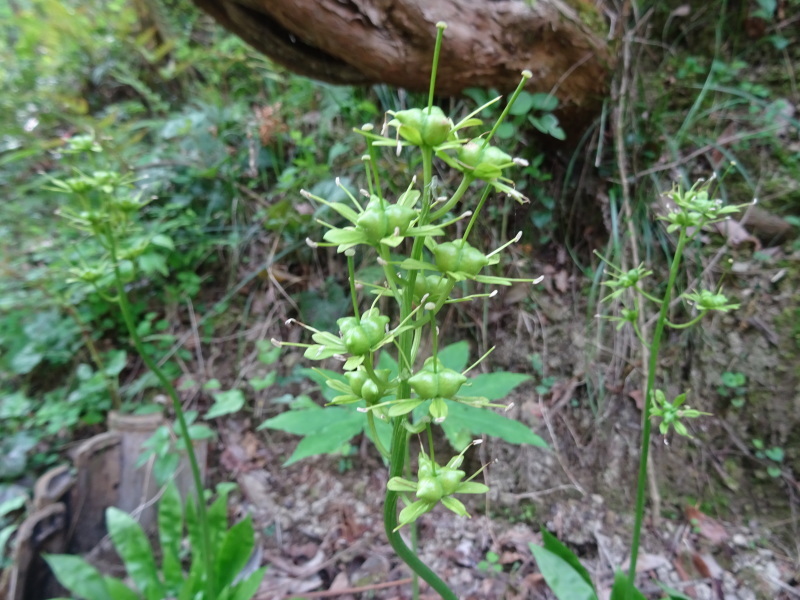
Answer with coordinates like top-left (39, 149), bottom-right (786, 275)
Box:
top-left (272, 23), bottom-right (545, 600)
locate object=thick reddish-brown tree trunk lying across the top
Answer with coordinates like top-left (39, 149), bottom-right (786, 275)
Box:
top-left (194, 0), bottom-right (612, 126)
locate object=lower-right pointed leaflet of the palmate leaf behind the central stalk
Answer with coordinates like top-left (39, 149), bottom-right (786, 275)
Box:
top-left (442, 402), bottom-right (548, 448)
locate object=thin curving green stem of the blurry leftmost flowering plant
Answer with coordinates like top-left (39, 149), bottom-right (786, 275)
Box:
top-left (107, 233), bottom-right (217, 598)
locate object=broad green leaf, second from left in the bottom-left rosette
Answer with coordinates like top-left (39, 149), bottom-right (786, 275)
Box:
top-left (106, 506), bottom-right (165, 600)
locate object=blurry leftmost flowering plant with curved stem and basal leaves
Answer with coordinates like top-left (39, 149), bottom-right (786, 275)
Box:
top-left (44, 136), bottom-right (262, 600)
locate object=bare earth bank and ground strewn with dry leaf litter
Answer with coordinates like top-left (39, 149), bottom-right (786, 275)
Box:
top-left (208, 232), bottom-right (800, 600)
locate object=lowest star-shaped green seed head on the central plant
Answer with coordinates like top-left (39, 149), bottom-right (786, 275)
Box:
top-left (387, 441), bottom-right (489, 531)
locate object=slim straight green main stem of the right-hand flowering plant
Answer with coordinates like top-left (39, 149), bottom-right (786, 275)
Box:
top-left (628, 230), bottom-right (686, 600)
